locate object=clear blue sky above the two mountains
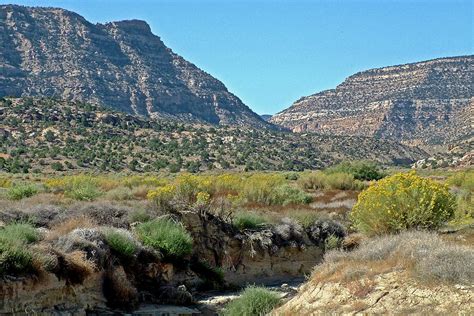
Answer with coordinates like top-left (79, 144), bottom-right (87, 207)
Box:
top-left (0, 0), bottom-right (474, 114)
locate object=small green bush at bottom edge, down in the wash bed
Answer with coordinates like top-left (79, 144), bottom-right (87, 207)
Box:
top-left (224, 286), bottom-right (280, 316)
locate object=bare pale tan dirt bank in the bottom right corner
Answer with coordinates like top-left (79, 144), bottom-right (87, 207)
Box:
top-left (271, 272), bottom-right (474, 316)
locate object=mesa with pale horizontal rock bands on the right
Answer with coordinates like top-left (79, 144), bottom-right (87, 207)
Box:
top-left (270, 56), bottom-right (474, 145)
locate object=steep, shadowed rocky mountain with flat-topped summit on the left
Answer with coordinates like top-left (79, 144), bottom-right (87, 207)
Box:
top-left (0, 5), bottom-right (270, 127)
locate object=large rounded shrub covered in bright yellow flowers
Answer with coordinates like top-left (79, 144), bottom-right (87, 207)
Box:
top-left (351, 172), bottom-right (456, 235)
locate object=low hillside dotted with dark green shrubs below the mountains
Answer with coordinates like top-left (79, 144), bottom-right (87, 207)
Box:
top-left (0, 98), bottom-right (427, 173)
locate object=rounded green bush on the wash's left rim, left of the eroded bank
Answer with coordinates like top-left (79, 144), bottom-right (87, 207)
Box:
top-left (136, 218), bottom-right (193, 258)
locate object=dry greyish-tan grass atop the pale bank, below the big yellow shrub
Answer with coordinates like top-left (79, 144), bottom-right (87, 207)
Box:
top-left (311, 232), bottom-right (474, 284)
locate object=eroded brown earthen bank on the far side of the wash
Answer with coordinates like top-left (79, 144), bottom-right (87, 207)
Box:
top-left (179, 212), bottom-right (323, 286)
